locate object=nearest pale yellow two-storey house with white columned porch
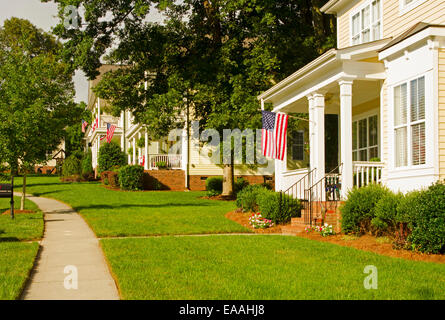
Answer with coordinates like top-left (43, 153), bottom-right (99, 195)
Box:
top-left (258, 0), bottom-right (445, 202)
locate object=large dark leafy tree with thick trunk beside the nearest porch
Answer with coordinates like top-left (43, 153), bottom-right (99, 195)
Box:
top-left (47, 0), bottom-right (335, 195)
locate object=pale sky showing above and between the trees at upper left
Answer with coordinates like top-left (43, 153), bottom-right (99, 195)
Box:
top-left (0, 0), bottom-right (165, 103)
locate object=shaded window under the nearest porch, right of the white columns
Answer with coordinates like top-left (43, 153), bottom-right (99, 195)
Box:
top-left (352, 115), bottom-right (379, 161)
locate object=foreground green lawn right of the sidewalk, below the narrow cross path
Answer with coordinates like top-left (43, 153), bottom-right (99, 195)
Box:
top-left (101, 236), bottom-right (445, 300)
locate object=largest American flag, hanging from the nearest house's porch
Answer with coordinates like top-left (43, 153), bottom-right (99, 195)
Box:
top-left (262, 111), bottom-right (289, 161)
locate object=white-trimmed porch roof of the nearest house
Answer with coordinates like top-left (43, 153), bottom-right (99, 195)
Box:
top-left (258, 38), bottom-right (392, 111)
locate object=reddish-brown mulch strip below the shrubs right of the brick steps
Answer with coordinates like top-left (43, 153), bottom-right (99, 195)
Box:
top-left (298, 232), bottom-right (445, 263)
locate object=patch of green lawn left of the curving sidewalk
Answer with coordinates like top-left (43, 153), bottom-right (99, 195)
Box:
top-left (0, 197), bottom-right (43, 300)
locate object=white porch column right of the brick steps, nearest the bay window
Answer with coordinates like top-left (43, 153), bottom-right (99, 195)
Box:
top-left (339, 80), bottom-right (353, 198)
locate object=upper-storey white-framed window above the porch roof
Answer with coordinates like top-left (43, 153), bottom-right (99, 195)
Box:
top-left (351, 0), bottom-right (382, 45)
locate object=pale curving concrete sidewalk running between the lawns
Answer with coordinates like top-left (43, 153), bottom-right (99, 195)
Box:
top-left (18, 194), bottom-right (119, 300)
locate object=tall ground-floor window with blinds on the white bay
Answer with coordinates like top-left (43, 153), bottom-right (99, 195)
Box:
top-left (394, 77), bottom-right (426, 167)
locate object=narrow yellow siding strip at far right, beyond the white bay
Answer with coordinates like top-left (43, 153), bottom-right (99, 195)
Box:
top-left (439, 49), bottom-right (445, 180)
